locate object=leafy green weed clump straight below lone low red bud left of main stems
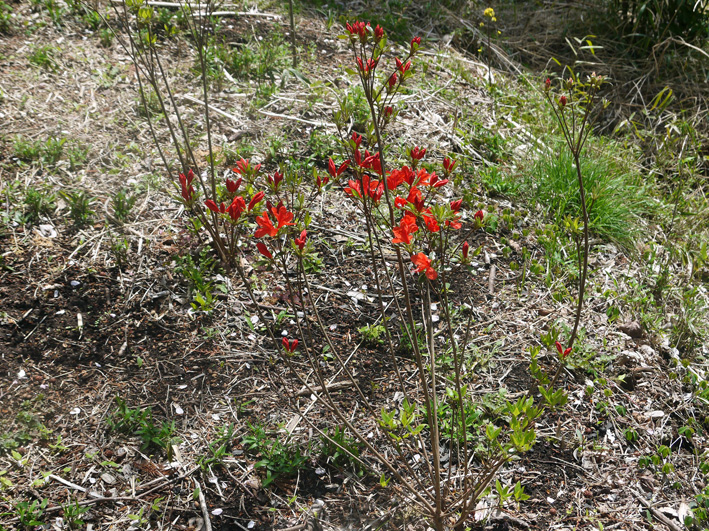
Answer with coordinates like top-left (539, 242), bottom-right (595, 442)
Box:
top-left (241, 423), bottom-right (307, 487)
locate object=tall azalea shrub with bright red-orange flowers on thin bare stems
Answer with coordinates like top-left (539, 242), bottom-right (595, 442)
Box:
top-left (121, 4), bottom-right (588, 530)
